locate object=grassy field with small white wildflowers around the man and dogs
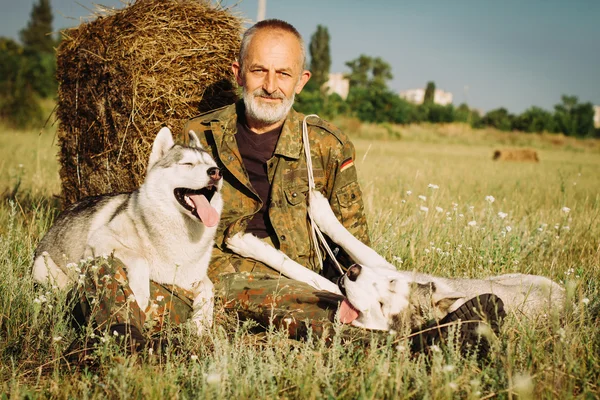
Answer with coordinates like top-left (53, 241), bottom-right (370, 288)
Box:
top-left (0, 123), bottom-right (600, 399)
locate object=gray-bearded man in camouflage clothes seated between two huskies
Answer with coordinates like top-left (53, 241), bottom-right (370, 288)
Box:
top-left (185, 19), bottom-right (369, 336)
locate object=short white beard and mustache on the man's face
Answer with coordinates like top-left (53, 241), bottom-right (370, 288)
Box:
top-left (244, 88), bottom-right (295, 125)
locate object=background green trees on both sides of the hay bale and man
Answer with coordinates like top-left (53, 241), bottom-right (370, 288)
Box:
top-left (0, 0), bottom-right (600, 137)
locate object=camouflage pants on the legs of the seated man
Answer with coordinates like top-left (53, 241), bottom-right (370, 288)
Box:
top-left (76, 259), bottom-right (352, 338)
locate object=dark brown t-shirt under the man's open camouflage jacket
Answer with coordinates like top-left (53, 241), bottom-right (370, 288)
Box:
top-left (235, 120), bottom-right (283, 238)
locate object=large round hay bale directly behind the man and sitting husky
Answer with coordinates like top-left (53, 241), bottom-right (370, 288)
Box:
top-left (57, 0), bottom-right (243, 205)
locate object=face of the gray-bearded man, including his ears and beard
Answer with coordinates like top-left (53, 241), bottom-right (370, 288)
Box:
top-left (233, 29), bottom-right (310, 125)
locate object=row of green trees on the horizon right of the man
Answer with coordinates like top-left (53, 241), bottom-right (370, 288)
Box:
top-left (297, 25), bottom-right (600, 138)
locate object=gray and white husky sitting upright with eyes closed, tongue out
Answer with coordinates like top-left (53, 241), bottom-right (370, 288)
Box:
top-left (33, 127), bottom-right (223, 334)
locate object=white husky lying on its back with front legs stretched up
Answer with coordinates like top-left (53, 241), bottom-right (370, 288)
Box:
top-left (227, 190), bottom-right (565, 330)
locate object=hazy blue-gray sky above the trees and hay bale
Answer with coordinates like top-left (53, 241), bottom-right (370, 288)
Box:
top-left (0, 0), bottom-right (600, 113)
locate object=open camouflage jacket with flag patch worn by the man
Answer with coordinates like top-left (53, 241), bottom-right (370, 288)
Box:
top-left (184, 101), bottom-right (369, 278)
